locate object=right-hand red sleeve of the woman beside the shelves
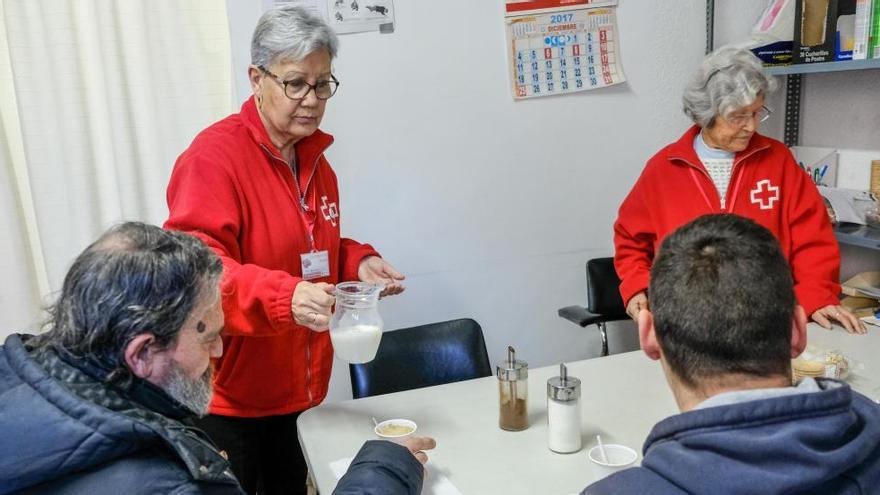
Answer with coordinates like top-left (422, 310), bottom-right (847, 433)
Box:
top-left (786, 154), bottom-right (840, 316)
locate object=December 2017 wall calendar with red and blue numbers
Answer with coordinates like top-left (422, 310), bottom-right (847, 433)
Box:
top-left (506, 0), bottom-right (626, 98)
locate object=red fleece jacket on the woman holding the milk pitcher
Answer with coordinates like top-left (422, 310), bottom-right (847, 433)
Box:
top-left (165, 97), bottom-right (378, 417)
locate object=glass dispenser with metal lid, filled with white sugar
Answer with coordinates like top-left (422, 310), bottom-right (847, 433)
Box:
top-left (547, 364), bottom-right (581, 454)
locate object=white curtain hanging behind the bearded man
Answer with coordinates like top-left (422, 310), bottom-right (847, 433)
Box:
top-left (0, 0), bottom-right (234, 337)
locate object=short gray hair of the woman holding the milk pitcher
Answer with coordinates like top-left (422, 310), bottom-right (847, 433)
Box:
top-left (251, 5), bottom-right (339, 67)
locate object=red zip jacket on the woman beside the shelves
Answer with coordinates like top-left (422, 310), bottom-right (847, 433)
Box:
top-left (614, 126), bottom-right (840, 316)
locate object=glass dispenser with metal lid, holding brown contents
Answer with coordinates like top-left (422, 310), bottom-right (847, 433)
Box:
top-left (495, 346), bottom-right (529, 431)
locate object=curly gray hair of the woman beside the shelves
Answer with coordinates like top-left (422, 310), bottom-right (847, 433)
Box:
top-left (682, 47), bottom-right (776, 127)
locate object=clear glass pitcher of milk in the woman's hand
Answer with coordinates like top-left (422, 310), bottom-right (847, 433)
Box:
top-left (330, 282), bottom-right (383, 363)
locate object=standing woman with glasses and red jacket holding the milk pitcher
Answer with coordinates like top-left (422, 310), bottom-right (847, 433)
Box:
top-left (165, 6), bottom-right (403, 494)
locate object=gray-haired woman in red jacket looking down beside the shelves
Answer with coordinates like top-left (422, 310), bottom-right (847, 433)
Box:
top-left (614, 48), bottom-right (865, 333)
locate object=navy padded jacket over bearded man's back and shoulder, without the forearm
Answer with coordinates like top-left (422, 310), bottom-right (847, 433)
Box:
top-left (0, 335), bottom-right (243, 495)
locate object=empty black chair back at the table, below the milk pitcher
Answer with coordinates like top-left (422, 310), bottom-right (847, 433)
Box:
top-left (348, 319), bottom-right (492, 399)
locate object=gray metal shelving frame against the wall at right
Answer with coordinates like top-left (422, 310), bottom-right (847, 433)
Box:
top-left (706, 0), bottom-right (880, 251)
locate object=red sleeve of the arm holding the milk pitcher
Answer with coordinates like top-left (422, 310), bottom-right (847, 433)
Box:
top-left (164, 154), bottom-right (301, 336)
